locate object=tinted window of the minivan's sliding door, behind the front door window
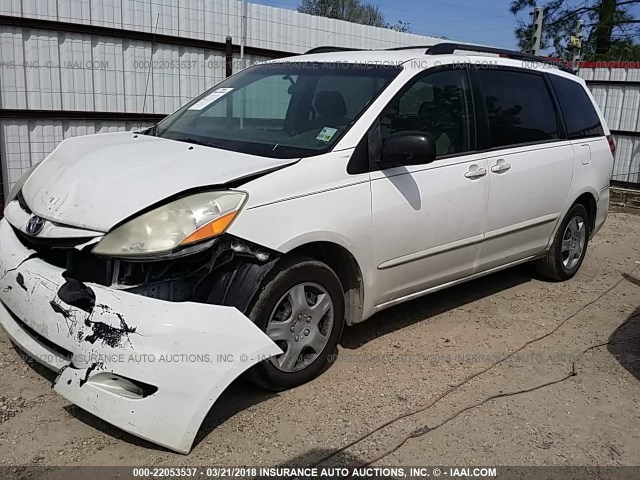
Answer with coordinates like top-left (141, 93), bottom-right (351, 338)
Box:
top-left (478, 70), bottom-right (558, 148)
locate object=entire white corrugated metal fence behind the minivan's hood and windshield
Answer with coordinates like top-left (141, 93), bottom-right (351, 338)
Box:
top-left (0, 0), bottom-right (440, 197)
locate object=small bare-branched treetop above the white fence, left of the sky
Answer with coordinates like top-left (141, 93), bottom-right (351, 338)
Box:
top-left (298, 0), bottom-right (382, 28)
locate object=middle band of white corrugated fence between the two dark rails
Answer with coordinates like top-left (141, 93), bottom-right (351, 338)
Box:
top-left (0, 26), bottom-right (268, 114)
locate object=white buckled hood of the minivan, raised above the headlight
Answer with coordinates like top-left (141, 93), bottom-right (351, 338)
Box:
top-left (22, 132), bottom-right (297, 232)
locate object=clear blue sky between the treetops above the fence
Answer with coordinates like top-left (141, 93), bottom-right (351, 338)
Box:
top-left (254, 0), bottom-right (517, 49)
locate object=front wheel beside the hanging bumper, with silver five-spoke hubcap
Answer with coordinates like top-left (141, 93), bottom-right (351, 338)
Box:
top-left (247, 257), bottom-right (344, 391)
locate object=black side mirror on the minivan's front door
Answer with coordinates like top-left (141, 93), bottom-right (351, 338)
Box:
top-left (382, 132), bottom-right (437, 166)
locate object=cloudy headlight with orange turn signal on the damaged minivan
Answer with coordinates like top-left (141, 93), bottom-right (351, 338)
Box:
top-left (93, 190), bottom-right (247, 257)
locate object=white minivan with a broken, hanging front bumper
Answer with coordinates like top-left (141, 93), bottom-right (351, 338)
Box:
top-left (0, 44), bottom-right (614, 453)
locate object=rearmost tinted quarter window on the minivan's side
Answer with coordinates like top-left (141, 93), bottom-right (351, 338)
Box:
top-left (549, 75), bottom-right (604, 138)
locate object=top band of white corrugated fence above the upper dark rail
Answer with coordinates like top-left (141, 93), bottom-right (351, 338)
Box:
top-left (0, 0), bottom-right (440, 53)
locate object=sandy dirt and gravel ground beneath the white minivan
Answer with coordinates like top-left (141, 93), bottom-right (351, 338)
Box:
top-left (0, 212), bottom-right (640, 466)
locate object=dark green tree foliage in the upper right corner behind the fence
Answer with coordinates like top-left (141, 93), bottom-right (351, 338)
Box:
top-left (510, 0), bottom-right (640, 60)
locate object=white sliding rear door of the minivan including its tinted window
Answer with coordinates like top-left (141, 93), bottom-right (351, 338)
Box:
top-left (472, 68), bottom-right (574, 271)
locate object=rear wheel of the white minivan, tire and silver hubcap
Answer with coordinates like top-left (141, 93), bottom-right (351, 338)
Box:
top-left (535, 204), bottom-right (591, 282)
